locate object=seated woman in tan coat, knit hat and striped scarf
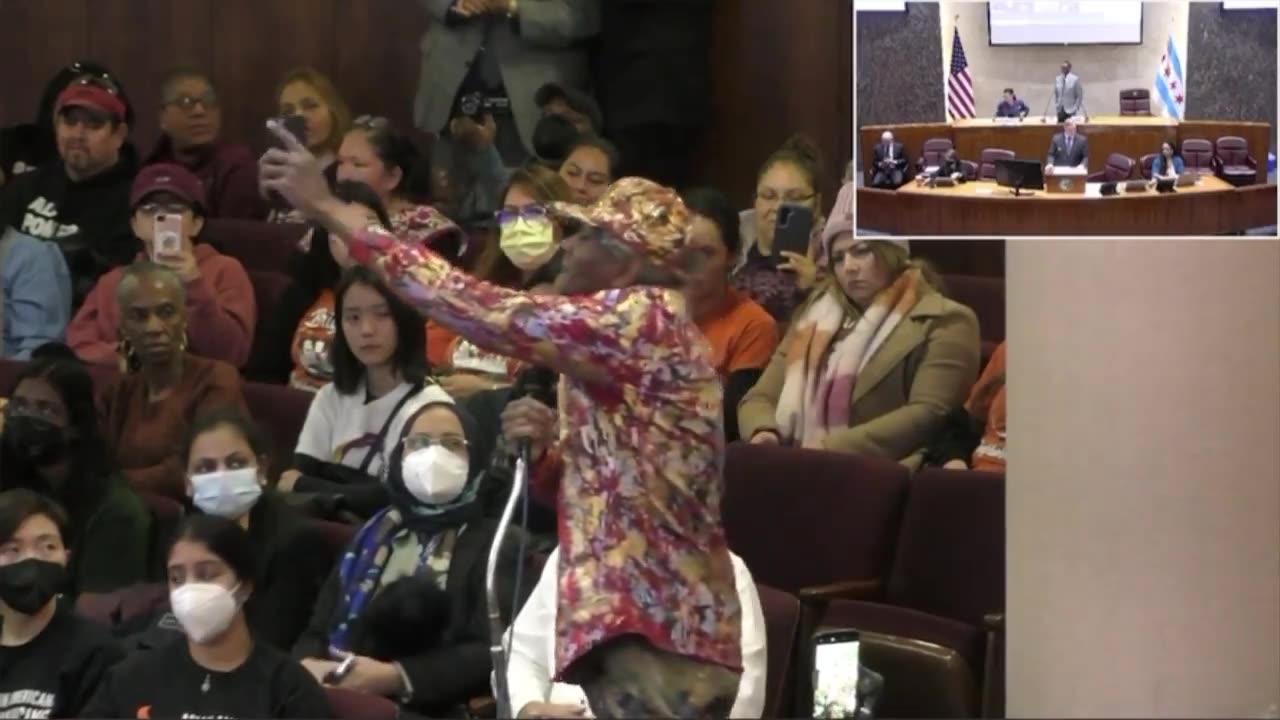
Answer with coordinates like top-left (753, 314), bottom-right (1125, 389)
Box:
top-left (739, 184), bottom-right (979, 468)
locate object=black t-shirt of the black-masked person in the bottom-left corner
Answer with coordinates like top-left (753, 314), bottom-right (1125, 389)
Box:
top-left (0, 601), bottom-right (124, 717)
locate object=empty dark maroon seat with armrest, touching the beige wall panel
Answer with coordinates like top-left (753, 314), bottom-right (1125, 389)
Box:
top-left (801, 469), bottom-right (1005, 716)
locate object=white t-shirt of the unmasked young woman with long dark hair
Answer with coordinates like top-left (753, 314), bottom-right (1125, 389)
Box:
top-left (294, 380), bottom-right (453, 477)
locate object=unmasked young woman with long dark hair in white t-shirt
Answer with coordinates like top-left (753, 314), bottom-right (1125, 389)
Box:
top-left (278, 265), bottom-right (452, 515)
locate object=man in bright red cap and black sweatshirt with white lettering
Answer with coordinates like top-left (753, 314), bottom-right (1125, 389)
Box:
top-left (0, 74), bottom-right (137, 307)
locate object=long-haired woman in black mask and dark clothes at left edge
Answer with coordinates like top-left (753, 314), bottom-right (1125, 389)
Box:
top-left (0, 357), bottom-right (151, 593)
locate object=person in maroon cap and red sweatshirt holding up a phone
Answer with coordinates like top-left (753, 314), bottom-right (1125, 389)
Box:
top-left (67, 164), bottom-right (257, 368)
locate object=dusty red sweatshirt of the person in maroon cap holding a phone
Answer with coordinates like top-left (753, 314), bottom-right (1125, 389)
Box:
top-left (67, 243), bottom-right (257, 368)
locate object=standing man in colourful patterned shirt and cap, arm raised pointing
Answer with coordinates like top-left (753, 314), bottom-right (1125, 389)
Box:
top-left (261, 120), bottom-right (742, 717)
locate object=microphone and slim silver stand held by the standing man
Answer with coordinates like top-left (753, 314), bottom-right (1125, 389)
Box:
top-left (484, 366), bottom-right (557, 717)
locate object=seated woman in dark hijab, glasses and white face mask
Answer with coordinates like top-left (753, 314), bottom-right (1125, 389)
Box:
top-left (293, 402), bottom-right (534, 717)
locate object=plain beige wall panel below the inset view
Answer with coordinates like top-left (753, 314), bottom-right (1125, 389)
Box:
top-left (1007, 240), bottom-right (1280, 717)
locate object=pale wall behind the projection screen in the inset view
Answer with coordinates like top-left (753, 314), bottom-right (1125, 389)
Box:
top-left (938, 1), bottom-right (1194, 118)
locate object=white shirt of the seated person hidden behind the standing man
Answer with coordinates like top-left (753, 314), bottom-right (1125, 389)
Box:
top-left (507, 548), bottom-right (768, 717)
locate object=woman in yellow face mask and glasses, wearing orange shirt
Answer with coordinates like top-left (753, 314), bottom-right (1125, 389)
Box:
top-left (426, 164), bottom-right (571, 400)
